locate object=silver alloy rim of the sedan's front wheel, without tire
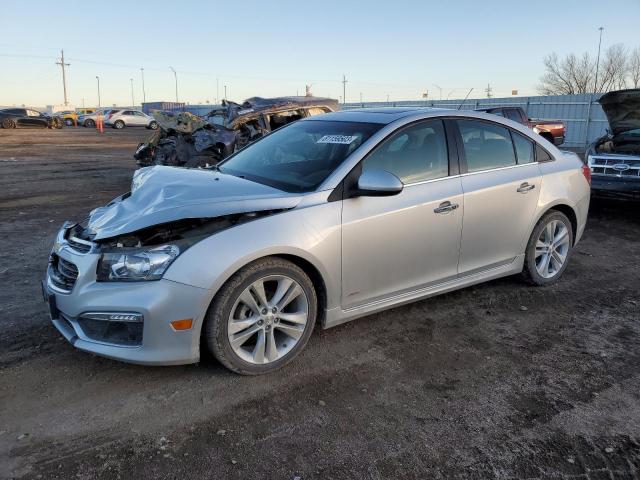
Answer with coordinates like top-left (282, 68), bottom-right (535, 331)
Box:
top-left (227, 275), bottom-right (309, 364)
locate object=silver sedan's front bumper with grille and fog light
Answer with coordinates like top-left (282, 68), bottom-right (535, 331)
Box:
top-left (43, 226), bottom-right (210, 365)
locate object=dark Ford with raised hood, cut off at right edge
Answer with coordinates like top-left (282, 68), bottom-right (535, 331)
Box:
top-left (585, 89), bottom-right (640, 200)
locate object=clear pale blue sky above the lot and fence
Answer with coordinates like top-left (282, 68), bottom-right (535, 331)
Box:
top-left (0, 0), bottom-right (640, 107)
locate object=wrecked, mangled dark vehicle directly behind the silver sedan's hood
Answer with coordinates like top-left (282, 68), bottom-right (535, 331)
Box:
top-left (134, 96), bottom-right (339, 167)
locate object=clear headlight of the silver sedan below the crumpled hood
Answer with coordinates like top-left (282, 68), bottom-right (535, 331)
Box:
top-left (97, 245), bottom-right (180, 282)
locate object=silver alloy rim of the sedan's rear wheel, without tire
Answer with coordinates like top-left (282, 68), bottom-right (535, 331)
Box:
top-left (535, 220), bottom-right (570, 278)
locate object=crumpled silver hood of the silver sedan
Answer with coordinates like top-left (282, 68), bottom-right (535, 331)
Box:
top-left (87, 166), bottom-right (301, 240)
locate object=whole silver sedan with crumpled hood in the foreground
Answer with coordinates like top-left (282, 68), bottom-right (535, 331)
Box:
top-left (43, 108), bottom-right (590, 374)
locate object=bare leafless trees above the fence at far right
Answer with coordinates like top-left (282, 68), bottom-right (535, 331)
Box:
top-left (538, 43), bottom-right (640, 95)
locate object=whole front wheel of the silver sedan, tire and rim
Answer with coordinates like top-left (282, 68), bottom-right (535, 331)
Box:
top-left (204, 257), bottom-right (318, 375)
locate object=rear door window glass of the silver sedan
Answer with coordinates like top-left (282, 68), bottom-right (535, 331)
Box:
top-left (458, 120), bottom-right (516, 172)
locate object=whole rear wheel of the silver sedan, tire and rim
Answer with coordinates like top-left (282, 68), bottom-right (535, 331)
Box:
top-left (523, 210), bottom-right (574, 286)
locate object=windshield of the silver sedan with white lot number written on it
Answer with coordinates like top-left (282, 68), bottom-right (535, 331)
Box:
top-left (220, 120), bottom-right (382, 192)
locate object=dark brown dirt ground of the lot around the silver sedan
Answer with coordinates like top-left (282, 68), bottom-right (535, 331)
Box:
top-left (0, 129), bottom-right (640, 480)
